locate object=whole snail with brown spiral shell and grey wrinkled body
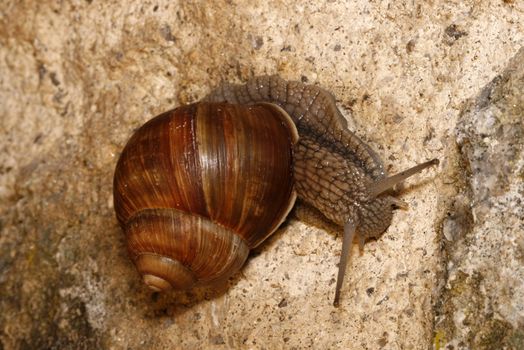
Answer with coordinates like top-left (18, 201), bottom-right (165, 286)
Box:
top-left (113, 76), bottom-right (438, 306)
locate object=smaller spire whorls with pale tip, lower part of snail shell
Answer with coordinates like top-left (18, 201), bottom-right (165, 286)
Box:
top-left (125, 209), bottom-right (249, 290)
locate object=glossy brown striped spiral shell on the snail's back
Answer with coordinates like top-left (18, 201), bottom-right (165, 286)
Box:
top-left (114, 103), bottom-right (298, 290)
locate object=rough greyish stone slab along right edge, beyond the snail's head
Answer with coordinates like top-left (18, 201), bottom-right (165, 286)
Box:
top-left (436, 48), bottom-right (524, 349)
